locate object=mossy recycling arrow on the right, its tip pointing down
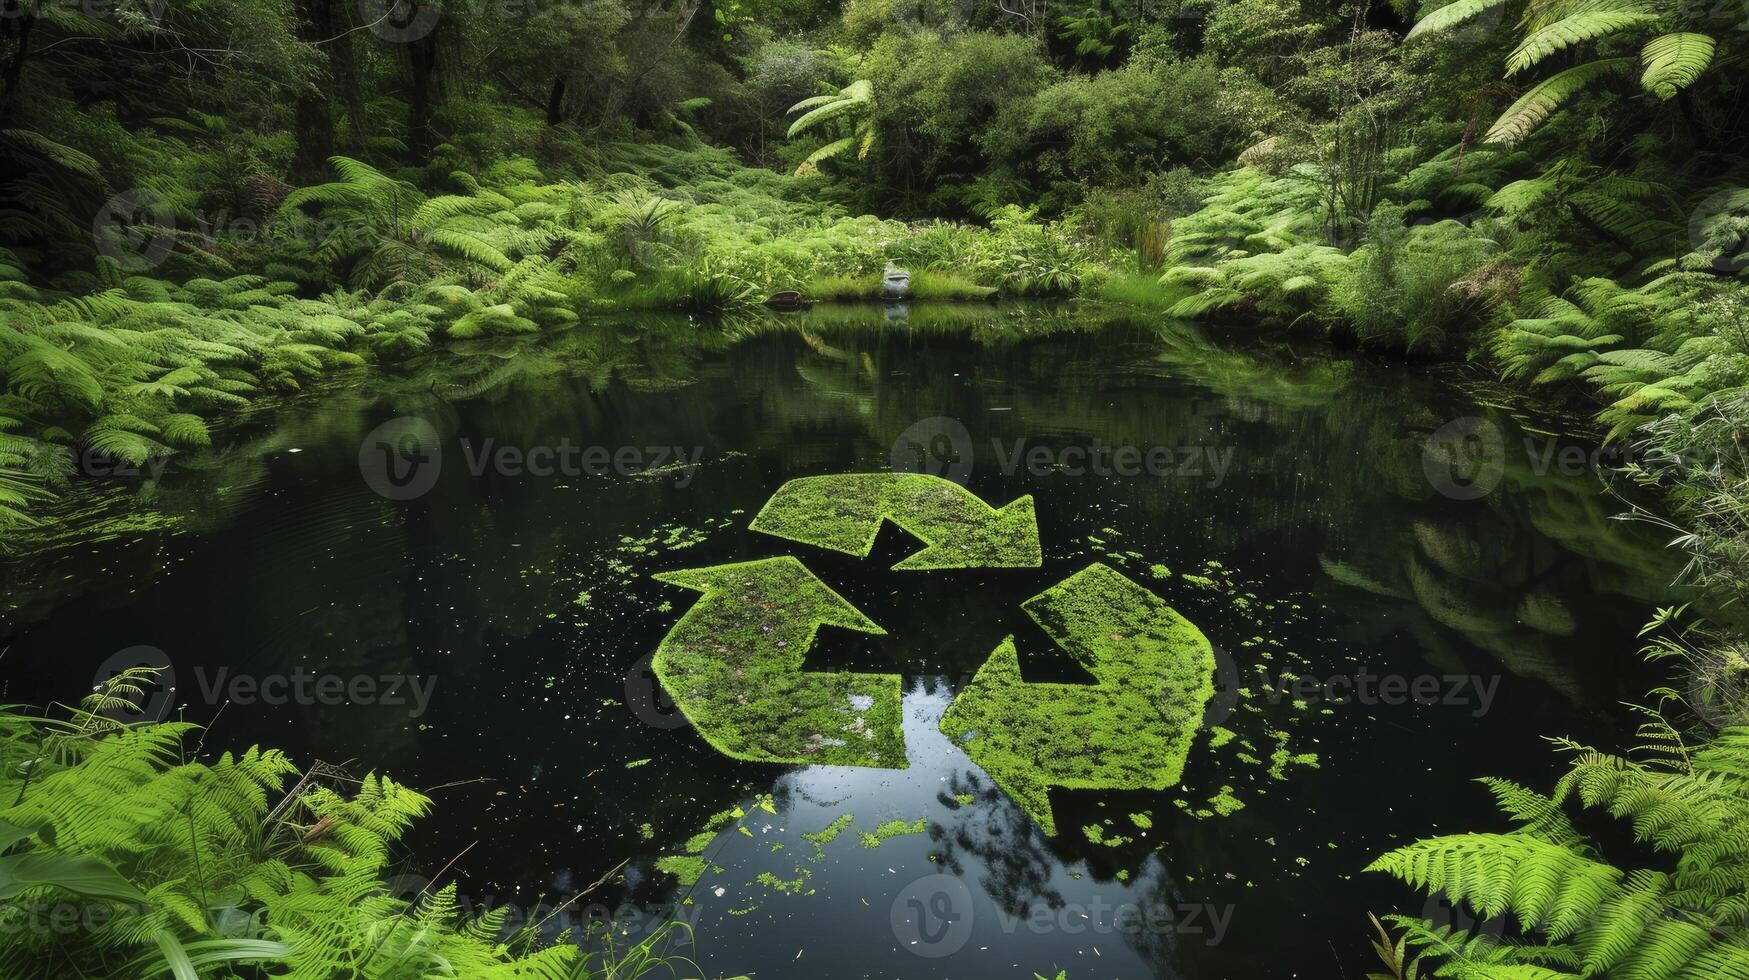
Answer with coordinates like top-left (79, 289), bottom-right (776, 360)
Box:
top-left (941, 565), bottom-right (1214, 835)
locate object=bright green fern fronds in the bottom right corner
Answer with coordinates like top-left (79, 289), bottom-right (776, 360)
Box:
top-left (1368, 712), bottom-right (1749, 980)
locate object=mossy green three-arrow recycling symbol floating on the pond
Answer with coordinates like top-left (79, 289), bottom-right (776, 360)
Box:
top-left (651, 473), bottom-right (1214, 835)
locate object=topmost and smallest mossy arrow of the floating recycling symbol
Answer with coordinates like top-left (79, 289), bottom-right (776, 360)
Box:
top-left (750, 473), bottom-right (1042, 571)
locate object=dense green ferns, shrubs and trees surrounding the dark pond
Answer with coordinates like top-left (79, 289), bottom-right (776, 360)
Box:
top-left (0, 0), bottom-right (1749, 980)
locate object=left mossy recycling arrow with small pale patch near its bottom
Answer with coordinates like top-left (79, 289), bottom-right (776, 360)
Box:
top-left (651, 557), bottom-right (906, 768)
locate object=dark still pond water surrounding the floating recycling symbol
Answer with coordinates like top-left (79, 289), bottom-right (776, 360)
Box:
top-left (3, 306), bottom-right (1674, 980)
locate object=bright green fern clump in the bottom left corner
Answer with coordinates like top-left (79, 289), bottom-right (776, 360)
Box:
top-left (0, 669), bottom-right (710, 980)
